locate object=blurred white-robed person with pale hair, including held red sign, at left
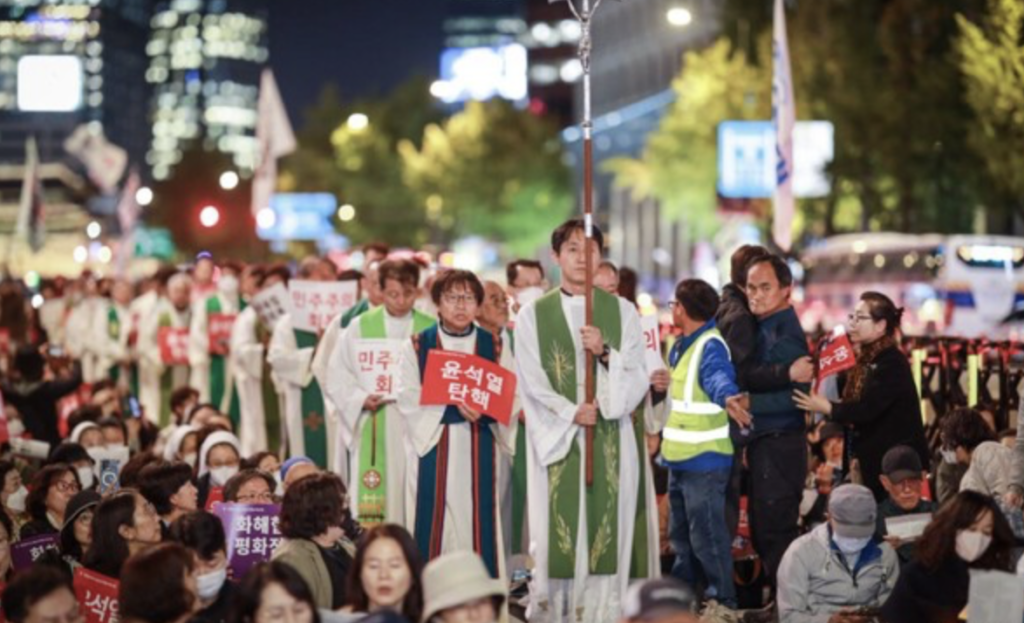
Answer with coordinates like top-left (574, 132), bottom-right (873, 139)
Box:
top-left (138, 273), bottom-right (191, 427)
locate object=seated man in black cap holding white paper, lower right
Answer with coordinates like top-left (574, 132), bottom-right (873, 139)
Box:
top-left (878, 446), bottom-right (935, 565)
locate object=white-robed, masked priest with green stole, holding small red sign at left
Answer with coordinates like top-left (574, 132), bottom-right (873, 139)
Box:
top-left (188, 261), bottom-right (246, 429)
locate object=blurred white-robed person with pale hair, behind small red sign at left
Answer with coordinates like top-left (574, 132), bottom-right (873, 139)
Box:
top-left (138, 273), bottom-right (191, 427)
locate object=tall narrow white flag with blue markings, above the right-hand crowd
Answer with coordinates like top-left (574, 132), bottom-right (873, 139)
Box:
top-left (771, 0), bottom-right (797, 251)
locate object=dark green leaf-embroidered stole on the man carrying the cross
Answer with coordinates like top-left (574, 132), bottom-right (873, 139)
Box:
top-left (536, 289), bottom-right (622, 579)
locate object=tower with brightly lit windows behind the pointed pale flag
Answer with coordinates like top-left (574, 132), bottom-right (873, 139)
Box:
top-left (145, 0), bottom-right (268, 179)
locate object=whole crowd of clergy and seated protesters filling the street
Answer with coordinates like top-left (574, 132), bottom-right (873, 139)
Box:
top-left (0, 215), bottom-right (1024, 623)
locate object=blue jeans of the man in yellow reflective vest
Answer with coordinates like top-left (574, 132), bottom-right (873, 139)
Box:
top-left (669, 469), bottom-right (736, 608)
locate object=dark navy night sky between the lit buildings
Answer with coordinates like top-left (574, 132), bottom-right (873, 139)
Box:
top-left (270, 0), bottom-right (444, 128)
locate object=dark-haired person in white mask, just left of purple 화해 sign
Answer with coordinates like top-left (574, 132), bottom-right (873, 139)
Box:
top-left (168, 510), bottom-right (236, 623)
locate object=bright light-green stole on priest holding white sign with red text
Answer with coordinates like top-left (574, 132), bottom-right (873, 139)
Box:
top-left (355, 305), bottom-right (437, 527)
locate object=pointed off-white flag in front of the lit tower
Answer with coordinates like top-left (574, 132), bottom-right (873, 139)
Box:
top-left (251, 69), bottom-right (296, 214)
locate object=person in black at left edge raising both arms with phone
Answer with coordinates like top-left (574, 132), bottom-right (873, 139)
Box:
top-left (0, 345), bottom-right (82, 448)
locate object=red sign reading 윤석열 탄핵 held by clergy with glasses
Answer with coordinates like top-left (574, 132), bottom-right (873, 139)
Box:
top-left (420, 348), bottom-right (516, 426)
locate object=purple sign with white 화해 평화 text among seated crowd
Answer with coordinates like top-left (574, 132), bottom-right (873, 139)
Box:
top-left (213, 503), bottom-right (282, 579)
